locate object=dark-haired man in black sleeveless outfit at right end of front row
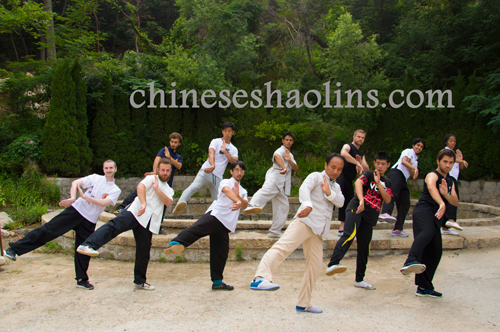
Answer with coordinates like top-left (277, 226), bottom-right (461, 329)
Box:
top-left (400, 149), bottom-right (458, 297)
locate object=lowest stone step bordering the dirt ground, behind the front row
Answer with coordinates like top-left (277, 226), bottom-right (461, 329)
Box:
top-left (42, 210), bottom-right (500, 261)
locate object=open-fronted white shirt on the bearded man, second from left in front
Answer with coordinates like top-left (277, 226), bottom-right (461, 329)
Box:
top-left (128, 175), bottom-right (174, 234)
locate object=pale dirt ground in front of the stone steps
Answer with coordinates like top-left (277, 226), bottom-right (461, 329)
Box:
top-left (0, 248), bottom-right (500, 332)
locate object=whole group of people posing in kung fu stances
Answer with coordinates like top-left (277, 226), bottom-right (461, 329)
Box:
top-left (4, 122), bottom-right (468, 313)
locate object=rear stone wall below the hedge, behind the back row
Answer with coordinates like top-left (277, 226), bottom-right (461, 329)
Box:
top-left (47, 175), bottom-right (500, 206)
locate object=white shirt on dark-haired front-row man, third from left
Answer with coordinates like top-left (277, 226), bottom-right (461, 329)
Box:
top-left (207, 178), bottom-right (248, 233)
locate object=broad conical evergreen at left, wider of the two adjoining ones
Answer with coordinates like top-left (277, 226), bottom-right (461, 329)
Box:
top-left (41, 59), bottom-right (80, 176)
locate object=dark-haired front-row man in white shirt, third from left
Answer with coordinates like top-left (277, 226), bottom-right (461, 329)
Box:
top-left (163, 160), bottom-right (248, 291)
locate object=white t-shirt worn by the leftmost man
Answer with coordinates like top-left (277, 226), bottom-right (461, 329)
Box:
top-left (71, 174), bottom-right (122, 224)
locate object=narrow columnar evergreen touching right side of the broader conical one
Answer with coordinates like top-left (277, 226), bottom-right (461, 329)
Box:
top-left (71, 60), bottom-right (92, 175)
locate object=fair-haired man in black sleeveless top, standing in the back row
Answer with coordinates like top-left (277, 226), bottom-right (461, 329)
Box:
top-left (337, 129), bottom-right (370, 236)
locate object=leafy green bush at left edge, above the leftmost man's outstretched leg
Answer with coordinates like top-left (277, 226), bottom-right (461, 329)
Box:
top-left (0, 170), bottom-right (61, 229)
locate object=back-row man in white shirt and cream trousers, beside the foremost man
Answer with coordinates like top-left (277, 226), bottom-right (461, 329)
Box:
top-left (243, 131), bottom-right (299, 238)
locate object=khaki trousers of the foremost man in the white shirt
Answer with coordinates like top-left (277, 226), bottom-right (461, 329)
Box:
top-left (255, 219), bottom-right (323, 307)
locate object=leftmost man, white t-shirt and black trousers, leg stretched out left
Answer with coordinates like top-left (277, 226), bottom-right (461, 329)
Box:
top-left (4, 160), bottom-right (121, 290)
